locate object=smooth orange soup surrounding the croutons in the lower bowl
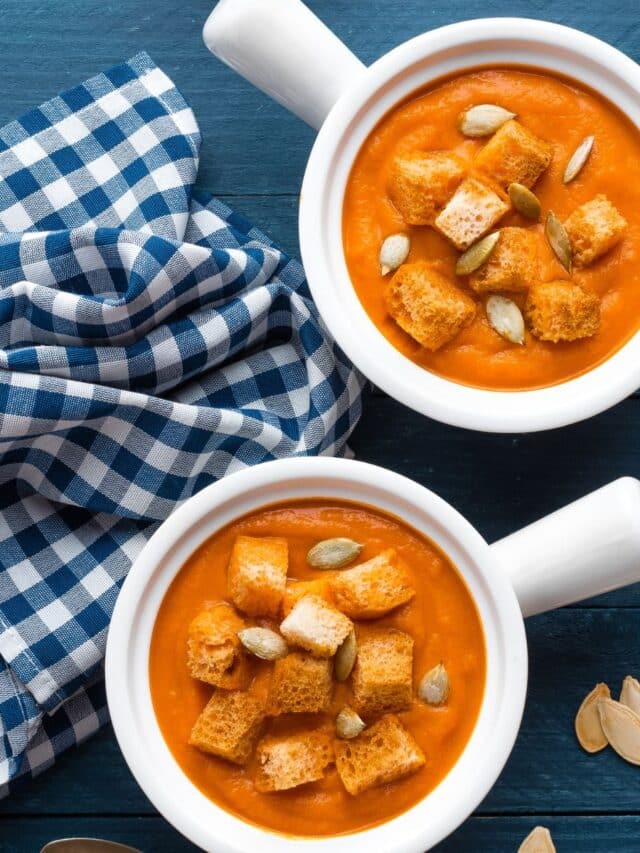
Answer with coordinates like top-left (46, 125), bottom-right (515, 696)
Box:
top-left (149, 499), bottom-right (486, 836)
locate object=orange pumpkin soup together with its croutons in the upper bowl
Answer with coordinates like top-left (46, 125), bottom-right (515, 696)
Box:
top-left (343, 68), bottom-right (640, 390)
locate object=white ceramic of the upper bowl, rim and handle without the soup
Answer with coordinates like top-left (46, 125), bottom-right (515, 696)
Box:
top-left (204, 5), bottom-right (640, 432)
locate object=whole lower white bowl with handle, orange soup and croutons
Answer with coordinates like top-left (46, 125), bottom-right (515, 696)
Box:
top-left (106, 458), bottom-right (640, 853)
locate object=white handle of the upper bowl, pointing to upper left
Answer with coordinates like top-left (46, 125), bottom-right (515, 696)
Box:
top-left (202, 0), bottom-right (365, 130)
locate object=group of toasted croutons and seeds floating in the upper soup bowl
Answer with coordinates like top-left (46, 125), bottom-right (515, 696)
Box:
top-left (380, 112), bottom-right (627, 351)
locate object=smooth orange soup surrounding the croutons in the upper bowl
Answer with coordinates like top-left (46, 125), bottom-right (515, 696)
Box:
top-left (343, 68), bottom-right (640, 390)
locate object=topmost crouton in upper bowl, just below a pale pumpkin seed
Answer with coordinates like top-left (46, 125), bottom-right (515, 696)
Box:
top-left (475, 119), bottom-right (553, 189)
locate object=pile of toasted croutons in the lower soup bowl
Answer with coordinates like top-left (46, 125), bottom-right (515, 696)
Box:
top-left (187, 536), bottom-right (440, 795)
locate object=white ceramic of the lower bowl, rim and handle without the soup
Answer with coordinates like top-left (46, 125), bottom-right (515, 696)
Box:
top-left (106, 457), bottom-right (640, 853)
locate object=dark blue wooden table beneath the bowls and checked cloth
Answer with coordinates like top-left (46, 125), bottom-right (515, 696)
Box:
top-left (0, 0), bottom-right (640, 853)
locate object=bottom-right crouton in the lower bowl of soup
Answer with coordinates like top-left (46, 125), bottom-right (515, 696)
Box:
top-left (335, 714), bottom-right (425, 796)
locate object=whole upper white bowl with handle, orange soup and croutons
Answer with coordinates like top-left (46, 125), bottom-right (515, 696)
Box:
top-left (204, 5), bottom-right (640, 432)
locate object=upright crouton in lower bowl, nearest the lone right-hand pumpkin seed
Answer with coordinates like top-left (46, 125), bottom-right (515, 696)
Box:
top-left (352, 628), bottom-right (413, 717)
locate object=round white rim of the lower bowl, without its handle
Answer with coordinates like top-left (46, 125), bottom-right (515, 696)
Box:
top-left (106, 457), bottom-right (527, 853)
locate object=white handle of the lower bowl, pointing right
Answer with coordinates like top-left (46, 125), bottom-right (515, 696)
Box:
top-left (491, 477), bottom-right (640, 616)
